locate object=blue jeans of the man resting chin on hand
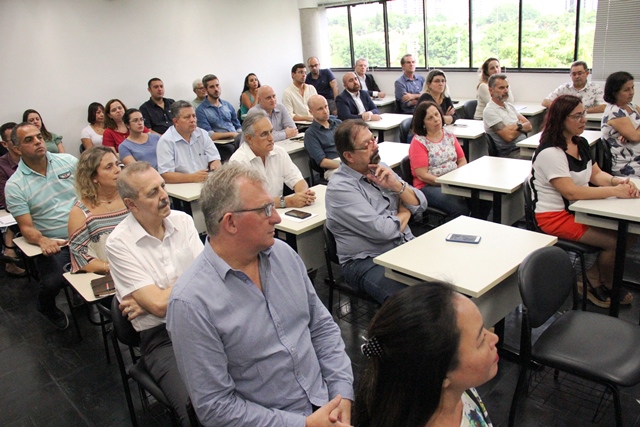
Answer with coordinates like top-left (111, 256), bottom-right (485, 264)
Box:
top-left (342, 258), bottom-right (407, 304)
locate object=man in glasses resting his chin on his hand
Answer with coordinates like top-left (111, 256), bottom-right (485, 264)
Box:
top-left (325, 119), bottom-right (427, 303)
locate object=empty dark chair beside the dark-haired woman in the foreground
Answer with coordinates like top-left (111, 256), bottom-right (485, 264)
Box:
top-left (509, 246), bottom-right (640, 426)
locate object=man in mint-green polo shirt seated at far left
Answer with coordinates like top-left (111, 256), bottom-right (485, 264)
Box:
top-left (5, 123), bottom-right (78, 329)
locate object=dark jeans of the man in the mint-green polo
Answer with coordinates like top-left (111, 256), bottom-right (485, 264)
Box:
top-left (35, 246), bottom-right (71, 312)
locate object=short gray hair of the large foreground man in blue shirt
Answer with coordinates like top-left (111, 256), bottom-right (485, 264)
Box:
top-left (200, 162), bottom-right (266, 236)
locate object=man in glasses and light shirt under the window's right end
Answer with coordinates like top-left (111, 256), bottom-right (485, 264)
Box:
top-left (542, 61), bottom-right (606, 113)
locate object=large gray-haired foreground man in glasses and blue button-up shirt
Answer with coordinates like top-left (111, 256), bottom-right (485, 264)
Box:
top-left (167, 162), bottom-right (354, 427)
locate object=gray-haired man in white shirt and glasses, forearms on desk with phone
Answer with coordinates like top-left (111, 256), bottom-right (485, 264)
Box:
top-left (229, 109), bottom-right (316, 208)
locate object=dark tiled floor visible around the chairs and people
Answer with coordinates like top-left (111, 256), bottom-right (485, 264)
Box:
top-left (0, 244), bottom-right (640, 427)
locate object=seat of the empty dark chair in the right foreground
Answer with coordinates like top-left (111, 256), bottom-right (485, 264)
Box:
top-left (532, 311), bottom-right (640, 387)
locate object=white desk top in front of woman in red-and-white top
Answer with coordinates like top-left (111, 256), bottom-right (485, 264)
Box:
top-left (436, 156), bottom-right (531, 194)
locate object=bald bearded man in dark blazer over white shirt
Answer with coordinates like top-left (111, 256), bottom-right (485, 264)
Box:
top-left (336, 72), bottom-right (382, 122)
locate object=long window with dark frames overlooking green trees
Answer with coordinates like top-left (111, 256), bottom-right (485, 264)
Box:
top-left (327, 0), bottom-right (598, 69)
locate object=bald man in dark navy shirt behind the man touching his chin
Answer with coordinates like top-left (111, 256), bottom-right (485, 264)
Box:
top-left (304, 95), bottom-right (342, 181)
